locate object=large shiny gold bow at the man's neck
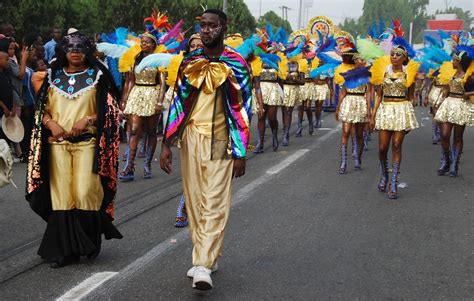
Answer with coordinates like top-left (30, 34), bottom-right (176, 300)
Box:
top-left (184, 59), bottom-right (232, 94)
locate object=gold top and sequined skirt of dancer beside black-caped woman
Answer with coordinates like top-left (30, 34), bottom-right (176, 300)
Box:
top-left (123, 67), bottom-right (160, 117)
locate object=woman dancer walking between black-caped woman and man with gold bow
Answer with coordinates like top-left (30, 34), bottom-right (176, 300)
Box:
top-left (119, 32), bottom-right (166, 182)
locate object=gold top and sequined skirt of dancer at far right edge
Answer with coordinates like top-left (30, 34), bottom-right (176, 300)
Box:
top-left (435, 77), bottom-right (470, 125)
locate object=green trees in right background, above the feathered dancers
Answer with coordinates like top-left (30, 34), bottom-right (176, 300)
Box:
top-left (340, 0), bottom-right (429, 43)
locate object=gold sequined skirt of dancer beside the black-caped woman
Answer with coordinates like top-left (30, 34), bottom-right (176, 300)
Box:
top-left (123, 86), bottom-right (160, 117)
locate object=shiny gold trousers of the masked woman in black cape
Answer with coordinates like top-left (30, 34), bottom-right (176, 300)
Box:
top-left (49, 139), bottom-right (104, 211)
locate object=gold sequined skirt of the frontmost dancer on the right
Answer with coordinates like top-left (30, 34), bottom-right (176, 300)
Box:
top-left (375, 100), bottom-right (419, 132)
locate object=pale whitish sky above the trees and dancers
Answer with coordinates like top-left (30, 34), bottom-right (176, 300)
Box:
top-left (244, 0), bottom-right (474, 30)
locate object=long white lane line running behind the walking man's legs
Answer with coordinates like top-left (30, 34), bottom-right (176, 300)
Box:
top-left (56, 124), bottom-right (341, 300)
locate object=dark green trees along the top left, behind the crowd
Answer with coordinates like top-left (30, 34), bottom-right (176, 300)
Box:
top-left (0, 0), bottom-right (256, 39)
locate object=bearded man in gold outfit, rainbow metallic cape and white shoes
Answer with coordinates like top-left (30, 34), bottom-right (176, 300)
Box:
top-left (160, 9), bottom-right (252, 290)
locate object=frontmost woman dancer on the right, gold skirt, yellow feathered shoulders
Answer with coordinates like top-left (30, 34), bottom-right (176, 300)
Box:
top-left (371, 44), bottom-right (419, 199)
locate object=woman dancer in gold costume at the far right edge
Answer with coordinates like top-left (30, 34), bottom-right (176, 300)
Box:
top-left (434, 51), bottom-right (472, 177)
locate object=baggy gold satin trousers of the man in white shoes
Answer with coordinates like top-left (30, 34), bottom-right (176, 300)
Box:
top-left (181, 124), bottom-right (233, 269)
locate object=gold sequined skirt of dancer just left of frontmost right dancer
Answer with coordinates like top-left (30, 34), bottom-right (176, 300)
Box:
top-left (339, 95), bottom-right (369, 123)
